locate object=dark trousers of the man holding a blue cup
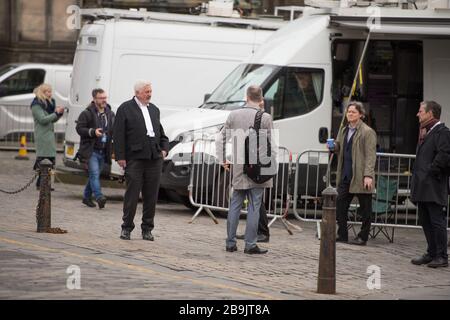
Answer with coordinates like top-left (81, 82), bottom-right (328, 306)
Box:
top-left (336, 181), bottom-right (372, 241)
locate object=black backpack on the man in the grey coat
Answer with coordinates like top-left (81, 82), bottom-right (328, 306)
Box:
top-left (244, 110), bottom-right (275, 184)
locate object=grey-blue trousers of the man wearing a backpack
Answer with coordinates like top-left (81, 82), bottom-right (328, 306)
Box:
top-left (226, 188), bottom-right (264, 249)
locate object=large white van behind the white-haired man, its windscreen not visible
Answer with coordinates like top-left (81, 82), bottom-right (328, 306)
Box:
top-left (64, 9), bottom-right (285, 175)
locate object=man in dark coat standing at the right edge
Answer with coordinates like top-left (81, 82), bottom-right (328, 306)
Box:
top-left (411, 101), bottom-right (450, 268)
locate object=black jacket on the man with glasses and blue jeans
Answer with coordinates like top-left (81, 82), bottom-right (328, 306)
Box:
top-left (76, 102), bottom-right (115, 164)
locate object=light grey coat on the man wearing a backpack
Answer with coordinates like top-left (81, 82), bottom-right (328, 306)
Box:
top-left (216, 105), bottom-right (278, 190)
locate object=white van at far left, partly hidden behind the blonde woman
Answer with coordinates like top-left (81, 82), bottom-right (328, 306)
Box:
top-left (0, 63), bottom-right (72, 139)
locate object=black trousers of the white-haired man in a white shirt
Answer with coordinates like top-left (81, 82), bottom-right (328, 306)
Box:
top-left (122, 159), bottom-right (163, 232)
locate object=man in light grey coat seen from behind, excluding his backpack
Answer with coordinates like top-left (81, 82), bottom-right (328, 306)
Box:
top-left (216, 86), bottom-right (276, 254)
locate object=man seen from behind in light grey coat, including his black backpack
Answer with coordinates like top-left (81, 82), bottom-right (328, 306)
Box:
top-left (216, 86), bottom-right (276, 254)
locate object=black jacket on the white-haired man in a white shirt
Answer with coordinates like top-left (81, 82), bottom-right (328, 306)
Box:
top-left (113, 98), bottom-right (169, 161)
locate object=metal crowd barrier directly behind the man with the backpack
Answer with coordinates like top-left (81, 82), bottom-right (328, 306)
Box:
top-left (188, 140), bottom-right (301, 234)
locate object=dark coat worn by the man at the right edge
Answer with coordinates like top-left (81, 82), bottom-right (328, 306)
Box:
top-left (411, 123), bottom-right (450, 206)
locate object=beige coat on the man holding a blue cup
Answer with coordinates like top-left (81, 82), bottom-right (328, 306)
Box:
top-left (334, 121), bottom-right (377, 193)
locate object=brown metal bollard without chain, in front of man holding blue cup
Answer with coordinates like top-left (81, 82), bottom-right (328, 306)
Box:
top-left (317, 186), bottom-right (337, 294)
